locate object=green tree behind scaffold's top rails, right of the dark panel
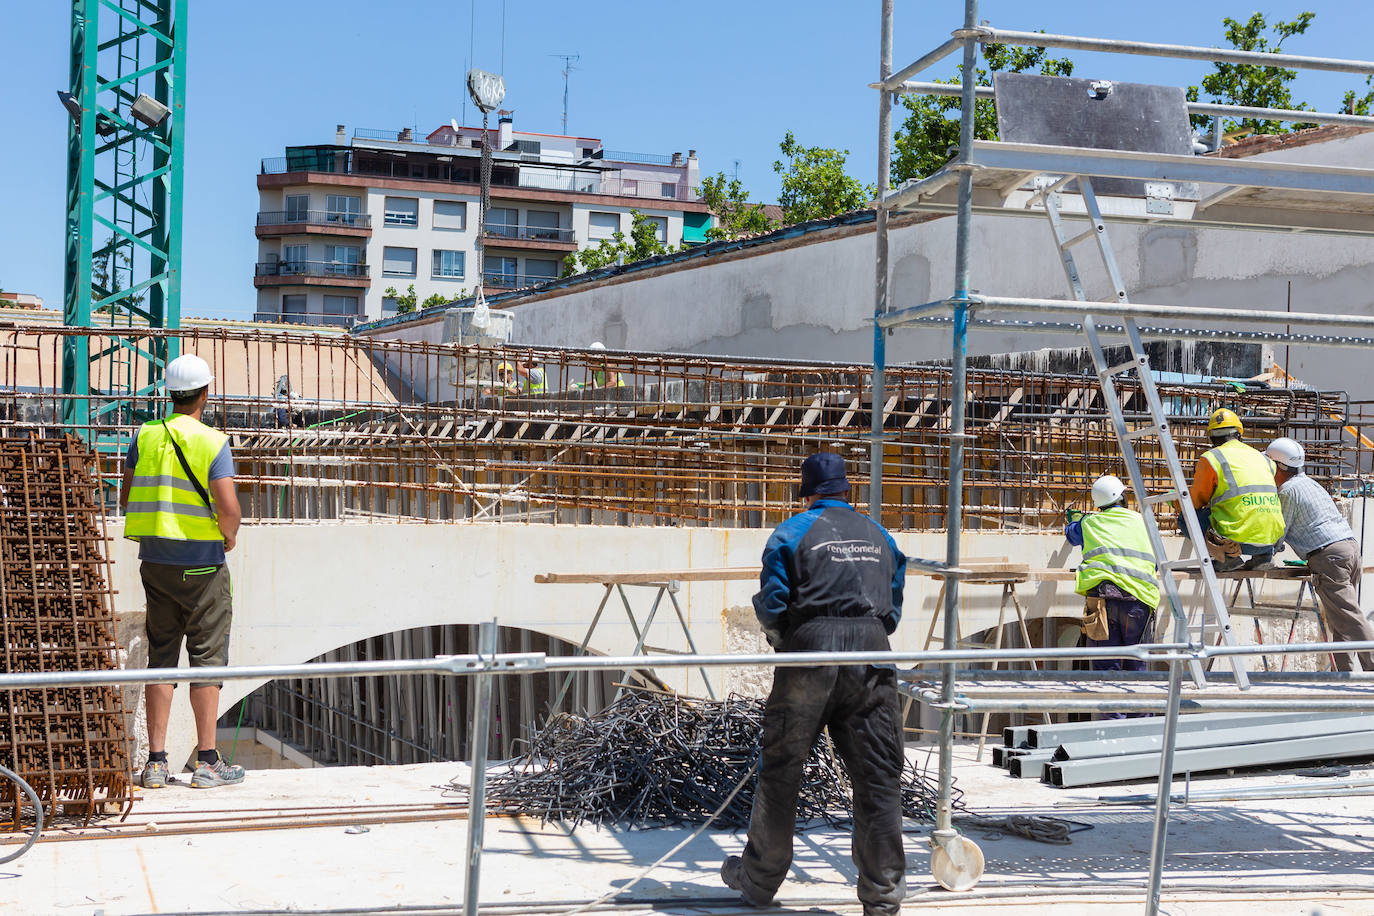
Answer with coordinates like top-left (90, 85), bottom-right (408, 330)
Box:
top-left (1187, 12), bottom-right (1313, 133)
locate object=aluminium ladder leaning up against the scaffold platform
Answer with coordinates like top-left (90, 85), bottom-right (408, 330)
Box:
top-left (1032, 176), bottom-right (1250, 689)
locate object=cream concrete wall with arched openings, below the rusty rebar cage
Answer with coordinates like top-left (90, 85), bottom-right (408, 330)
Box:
top-left (110, 525), bottom-right (1374, 762)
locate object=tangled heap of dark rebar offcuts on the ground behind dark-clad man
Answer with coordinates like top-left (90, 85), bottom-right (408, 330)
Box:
top-left (453, 689), bottom-right (958, 829)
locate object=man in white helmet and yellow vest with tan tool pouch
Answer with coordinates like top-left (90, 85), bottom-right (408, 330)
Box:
top-left (1063, 474), bottom-right (1160, 692)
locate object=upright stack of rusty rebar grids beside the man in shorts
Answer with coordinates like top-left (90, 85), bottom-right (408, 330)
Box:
top-left (0, 435), bottom-right (133, 827)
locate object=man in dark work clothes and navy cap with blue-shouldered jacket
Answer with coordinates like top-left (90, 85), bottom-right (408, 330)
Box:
top-left (720, 452), bottom-right (907, 916)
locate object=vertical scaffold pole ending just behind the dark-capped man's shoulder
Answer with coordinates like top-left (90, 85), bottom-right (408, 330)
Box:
top-left (868, 0), bottom-right (893, 525)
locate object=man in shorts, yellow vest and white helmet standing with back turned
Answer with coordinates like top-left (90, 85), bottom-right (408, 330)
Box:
top-left (120, 354), bottom-right (243, 788)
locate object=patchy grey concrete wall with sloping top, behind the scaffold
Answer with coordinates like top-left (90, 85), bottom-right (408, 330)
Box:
top-left (464, 135), bottom-right (1374, 397)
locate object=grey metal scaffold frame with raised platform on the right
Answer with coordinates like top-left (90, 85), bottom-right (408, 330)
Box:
top-left (870, 0), bottom-right (1374, 913)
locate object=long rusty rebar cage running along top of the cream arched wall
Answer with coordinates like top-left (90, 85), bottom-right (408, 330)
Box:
top-left (0, 327), bottom-right (1370, 530)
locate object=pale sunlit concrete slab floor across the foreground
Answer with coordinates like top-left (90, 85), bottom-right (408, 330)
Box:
top-left (10, 744), bottom-right (1374, 916)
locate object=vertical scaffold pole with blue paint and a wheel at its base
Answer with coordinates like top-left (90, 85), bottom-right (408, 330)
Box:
top-left (934, 0), bottom-right (978, 846)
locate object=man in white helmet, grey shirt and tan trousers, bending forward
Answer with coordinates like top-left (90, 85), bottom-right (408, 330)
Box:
top-left (1264, 437), bottom-right (1374, 672)
